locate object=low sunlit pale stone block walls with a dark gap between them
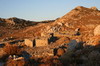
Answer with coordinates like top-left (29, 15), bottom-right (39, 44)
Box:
top-left (25, 36), bottom-right (58, 47)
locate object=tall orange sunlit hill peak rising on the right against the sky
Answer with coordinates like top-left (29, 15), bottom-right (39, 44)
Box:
top-left (55, 6), bottom-right (100, 28)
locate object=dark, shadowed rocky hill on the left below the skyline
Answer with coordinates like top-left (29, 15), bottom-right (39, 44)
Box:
top-left (0, 17), bottom-right (38, 29)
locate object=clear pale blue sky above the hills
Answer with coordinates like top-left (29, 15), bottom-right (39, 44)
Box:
top-left (0, 0), bottom-right (100, 21)
